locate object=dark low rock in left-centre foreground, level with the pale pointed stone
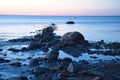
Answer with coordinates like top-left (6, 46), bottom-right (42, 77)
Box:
top-left (33, 67), bottom-right (48, 76)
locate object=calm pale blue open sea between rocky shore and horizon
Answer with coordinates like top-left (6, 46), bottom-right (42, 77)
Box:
top-left (0, 15), bottom-right (120, 42)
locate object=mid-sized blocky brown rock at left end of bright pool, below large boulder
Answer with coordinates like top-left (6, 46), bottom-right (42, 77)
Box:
top-left (46, 50), bottom-right (59, 61)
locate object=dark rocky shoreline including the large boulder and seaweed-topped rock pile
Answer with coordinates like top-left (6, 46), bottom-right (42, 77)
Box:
top-left (0, 24), bottom-right (120, 80)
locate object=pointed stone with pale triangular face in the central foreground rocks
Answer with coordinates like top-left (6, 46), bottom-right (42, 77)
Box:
top-left (67, 62), bottom-right (80, 73)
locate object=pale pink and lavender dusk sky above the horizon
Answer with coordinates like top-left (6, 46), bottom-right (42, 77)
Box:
top-left (0, 0), bottom-right (120, 16)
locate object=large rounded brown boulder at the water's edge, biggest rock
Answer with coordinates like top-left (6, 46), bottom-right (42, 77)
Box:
top-left (62, 32), bottom-right (85, 45)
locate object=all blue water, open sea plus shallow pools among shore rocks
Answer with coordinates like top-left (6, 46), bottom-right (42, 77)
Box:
top-left (0, 15), bottom-right (120, 80)
